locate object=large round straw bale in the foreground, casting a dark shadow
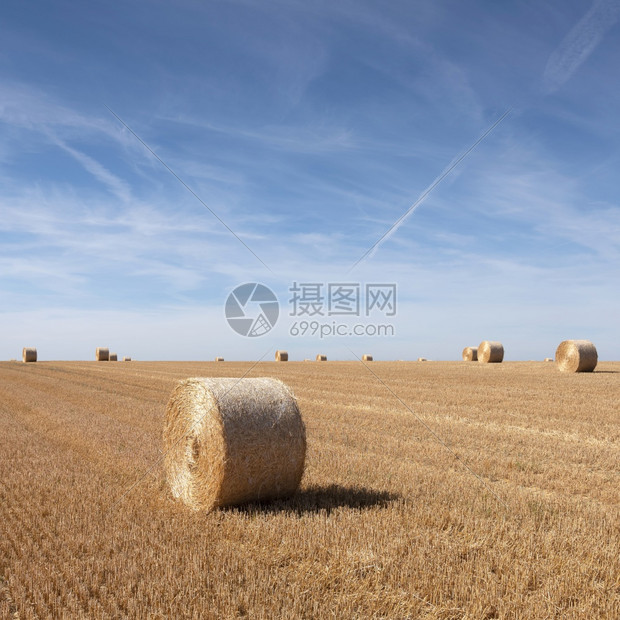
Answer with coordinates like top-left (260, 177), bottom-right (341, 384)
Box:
top-left (163, 377), bottom-right (306, 510)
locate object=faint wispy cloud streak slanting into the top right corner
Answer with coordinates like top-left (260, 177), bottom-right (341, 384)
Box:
top-left (543, 0), bottom-right (620, 94)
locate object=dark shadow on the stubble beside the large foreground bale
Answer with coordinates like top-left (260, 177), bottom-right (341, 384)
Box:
top-left (225, 484), bottom-right (400, 516)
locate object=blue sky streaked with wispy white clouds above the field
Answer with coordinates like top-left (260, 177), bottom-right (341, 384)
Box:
top-left (0, 0), bottom-right (620, 360)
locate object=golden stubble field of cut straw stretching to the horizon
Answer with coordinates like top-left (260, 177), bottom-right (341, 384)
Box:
top-left (0, 362), bottom-right (620, 619)
